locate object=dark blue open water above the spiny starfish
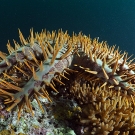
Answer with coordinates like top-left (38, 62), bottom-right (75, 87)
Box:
top-left (0, 0), bottom-right (135, 54)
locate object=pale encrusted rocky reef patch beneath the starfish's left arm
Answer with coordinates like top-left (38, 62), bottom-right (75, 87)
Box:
top-left (0, 95), bottom-right (77, 135)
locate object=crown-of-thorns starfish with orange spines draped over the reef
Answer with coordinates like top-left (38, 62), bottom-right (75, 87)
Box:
top-left (0, 29), bottom-right (135, 120)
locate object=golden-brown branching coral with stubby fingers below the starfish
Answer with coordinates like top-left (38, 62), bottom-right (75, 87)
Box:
top-left (70, 81), bottom-right (135, 135)
